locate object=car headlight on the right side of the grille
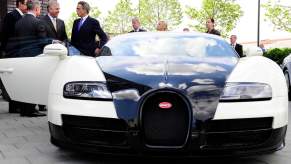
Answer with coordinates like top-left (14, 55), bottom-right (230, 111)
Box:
top-left (220, 83), bottom-right (272, 102)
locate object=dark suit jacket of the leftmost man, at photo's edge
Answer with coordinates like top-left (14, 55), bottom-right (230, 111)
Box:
top-left (1, 9), bottom-right (22, 50)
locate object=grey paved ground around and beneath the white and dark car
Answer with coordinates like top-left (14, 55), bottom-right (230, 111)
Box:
top-left (0, 97), bottom-right (291, 164)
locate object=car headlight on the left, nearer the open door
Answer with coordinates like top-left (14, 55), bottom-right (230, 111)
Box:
top-left (64, 82), bottom-right (112, 100)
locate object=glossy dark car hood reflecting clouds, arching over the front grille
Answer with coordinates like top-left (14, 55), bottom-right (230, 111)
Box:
top-left (97, 56), bottom-right (238, 121)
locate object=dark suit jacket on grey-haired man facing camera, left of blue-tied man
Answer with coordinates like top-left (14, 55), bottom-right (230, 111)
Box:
top-left (41, 15), bottom-right (68, 41)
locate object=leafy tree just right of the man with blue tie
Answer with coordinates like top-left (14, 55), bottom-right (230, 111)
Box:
top-left (103, 0), bottom-right (134, 34)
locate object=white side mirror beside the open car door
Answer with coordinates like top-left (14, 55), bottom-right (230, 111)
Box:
top-left (43, 43), bottom-right (68, 59)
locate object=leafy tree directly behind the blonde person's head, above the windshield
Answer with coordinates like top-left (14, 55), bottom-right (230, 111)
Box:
top-left (137, 0), bottom-right (183, 30)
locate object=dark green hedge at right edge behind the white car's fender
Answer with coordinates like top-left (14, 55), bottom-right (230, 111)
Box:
top-left (264, 48), bottom-right (291, 64)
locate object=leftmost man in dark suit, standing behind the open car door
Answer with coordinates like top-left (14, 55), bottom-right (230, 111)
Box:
top-left (0, 0), bottom-right (27, 113)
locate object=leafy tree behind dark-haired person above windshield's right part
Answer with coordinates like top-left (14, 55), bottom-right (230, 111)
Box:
top-left (186, 0), bottom-right (243, 36)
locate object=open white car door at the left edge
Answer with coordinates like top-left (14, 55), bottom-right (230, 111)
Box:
top-left (0, 55), bottom-right (60, 105)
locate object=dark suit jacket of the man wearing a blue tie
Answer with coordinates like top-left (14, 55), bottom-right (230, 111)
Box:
top-left (71, 16), bottom-right (108, 56)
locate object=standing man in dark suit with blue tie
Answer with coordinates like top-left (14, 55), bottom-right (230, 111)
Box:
top-left (71, 1), bottom-right (108, 56)
